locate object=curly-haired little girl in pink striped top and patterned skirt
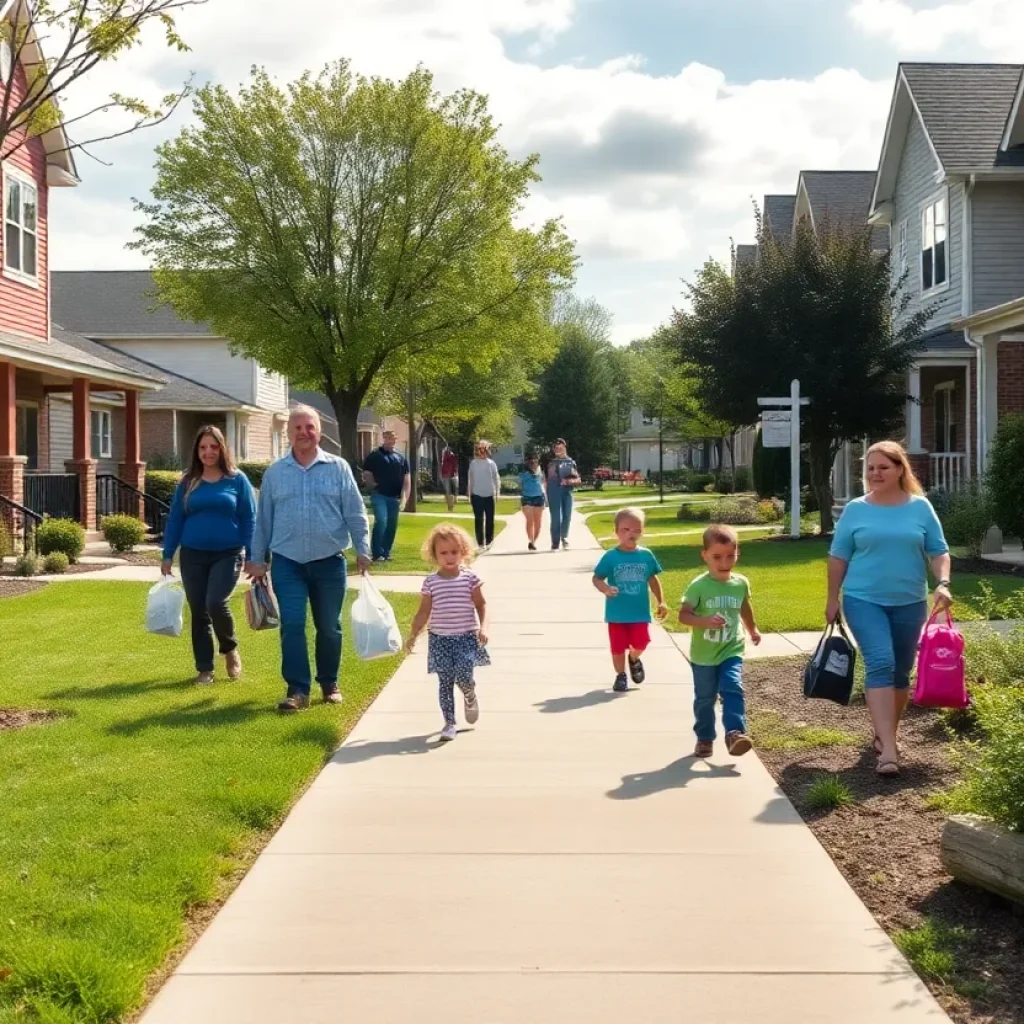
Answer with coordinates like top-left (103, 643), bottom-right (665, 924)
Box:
top-left (406, 522), bottom-right (490, 741)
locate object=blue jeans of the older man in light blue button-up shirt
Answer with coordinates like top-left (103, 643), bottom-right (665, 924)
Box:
top-left (270, 555), bottom-right (347, 696)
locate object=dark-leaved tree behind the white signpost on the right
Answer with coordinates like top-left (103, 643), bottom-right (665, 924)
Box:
top-left (672, 224), bottom-right (930, 532)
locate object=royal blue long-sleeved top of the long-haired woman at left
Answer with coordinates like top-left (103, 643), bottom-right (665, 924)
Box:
top-left (164, 472), bottom-right (256, 559)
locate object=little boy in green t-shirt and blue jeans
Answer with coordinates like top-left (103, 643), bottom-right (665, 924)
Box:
top-left (679, 525), bottom-right (761, 758)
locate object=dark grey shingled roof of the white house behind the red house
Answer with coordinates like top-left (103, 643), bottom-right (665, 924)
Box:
top-left (50, 270), bottom-right (217, 338)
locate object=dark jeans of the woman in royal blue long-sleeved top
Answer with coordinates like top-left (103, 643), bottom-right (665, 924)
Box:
top-left (178, 548), bottom-right (242, 672)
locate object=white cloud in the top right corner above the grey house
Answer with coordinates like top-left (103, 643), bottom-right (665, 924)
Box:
top-left (850, 0), bottom-right (1024, 62)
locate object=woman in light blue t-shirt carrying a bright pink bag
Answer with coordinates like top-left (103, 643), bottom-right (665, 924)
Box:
top-left (825, 441), bottom-right (952, 775)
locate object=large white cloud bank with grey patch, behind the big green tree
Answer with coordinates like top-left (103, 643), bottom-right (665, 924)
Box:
top-left (51, 0), bottom-right (891, 338)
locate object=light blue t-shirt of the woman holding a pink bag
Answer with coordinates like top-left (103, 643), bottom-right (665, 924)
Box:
top-left (829, 495), bottom-right (949, 607)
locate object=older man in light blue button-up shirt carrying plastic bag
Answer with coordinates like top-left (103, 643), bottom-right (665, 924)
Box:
top-left (246, 406), bottom-right (370, 712)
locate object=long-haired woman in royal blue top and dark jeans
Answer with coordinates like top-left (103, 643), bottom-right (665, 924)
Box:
top-left (161, 426), bottom-right (256, 684)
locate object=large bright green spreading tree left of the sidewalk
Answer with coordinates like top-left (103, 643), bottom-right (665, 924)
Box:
top-left (134, 61), bottom-right (575, 459)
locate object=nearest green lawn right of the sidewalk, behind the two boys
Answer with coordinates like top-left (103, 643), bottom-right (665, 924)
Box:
top-left (590, 517), bottom-right (1021, 633)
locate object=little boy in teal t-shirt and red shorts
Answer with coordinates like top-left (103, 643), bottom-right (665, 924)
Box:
top-left (593, 509), bottom-right (669, 693)
